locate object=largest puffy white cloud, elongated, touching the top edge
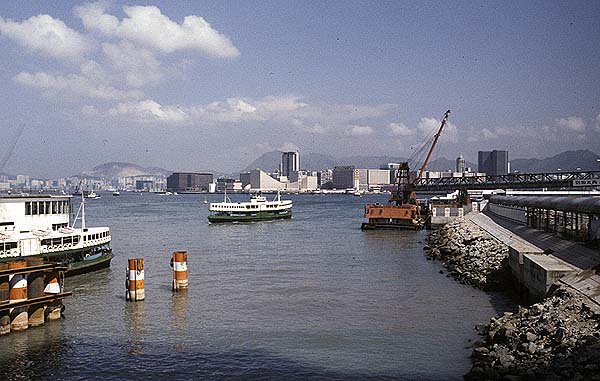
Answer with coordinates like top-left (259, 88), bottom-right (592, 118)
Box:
top-left (75, 3), bottom-right (240, 58)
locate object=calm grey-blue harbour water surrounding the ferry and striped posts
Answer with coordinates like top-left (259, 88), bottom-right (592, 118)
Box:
top-left (0, 193), bottom-right (510, 380)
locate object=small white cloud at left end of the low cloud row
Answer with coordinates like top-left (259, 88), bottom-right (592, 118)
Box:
top-left (108, 99), bottom-right (188, 123)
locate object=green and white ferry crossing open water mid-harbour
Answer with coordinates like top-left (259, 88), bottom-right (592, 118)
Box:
top-left (208, 192), bottom-right (292, 223)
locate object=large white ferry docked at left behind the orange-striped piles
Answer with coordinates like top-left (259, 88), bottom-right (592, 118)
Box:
top-left (0, 194), bottom-right (113, 275)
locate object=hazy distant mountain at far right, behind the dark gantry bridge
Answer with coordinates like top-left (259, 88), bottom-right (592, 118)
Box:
top-left (510, 150), bottom-right (600, 173)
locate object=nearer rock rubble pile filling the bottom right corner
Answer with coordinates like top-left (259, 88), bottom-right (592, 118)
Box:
top-left (465, 286), bottom-right (600, 380)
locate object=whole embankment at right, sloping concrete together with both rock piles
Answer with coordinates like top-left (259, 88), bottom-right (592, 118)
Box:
top-left (429, 206), bottom-right (600, 380)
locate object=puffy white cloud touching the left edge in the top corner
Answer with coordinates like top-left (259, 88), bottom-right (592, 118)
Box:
top-left (0, 15), bottom-right (93, 60)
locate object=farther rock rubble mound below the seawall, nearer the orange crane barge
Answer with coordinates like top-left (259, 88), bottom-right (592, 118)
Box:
top-left (426, 218), bottom-right (509, 290)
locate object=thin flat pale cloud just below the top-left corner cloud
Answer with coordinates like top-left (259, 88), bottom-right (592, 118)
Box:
top-left (15, 72), bottom-right (143, 100)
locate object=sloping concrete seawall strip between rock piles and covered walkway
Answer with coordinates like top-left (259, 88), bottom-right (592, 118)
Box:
top-left (466, 213), bottom-right (600, 301)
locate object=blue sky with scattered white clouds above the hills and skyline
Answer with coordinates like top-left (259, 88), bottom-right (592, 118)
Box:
top-left (0, 1), bottom-right (600, 177)
